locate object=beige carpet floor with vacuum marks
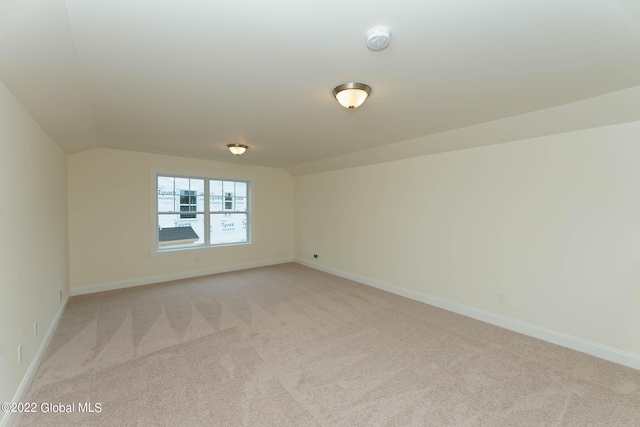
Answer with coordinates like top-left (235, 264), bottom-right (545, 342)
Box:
top-left (16, 263), bottom-right (640, 426)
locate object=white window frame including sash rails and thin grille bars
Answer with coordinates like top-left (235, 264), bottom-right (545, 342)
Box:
top-left (151, 170), bottom-right (253, 255)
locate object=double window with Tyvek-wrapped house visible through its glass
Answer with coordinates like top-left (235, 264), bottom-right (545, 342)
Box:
top-left (156, 175), bottom-right (249, 251)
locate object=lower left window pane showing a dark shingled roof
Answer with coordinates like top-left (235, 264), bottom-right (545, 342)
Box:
top-left (158, 214), bottom-right (204, 249)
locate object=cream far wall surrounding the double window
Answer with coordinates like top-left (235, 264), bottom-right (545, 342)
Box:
top-left (68, 148), bottom-right (293, 294)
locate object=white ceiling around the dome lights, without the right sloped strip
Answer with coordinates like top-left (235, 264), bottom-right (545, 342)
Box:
top-left (0, 0), bottom-right (640, 173)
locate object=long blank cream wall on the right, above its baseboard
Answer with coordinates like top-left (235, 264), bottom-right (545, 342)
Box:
top-left (295, 122), bottom-right (640, 366)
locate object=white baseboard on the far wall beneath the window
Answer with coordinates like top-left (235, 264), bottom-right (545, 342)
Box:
top-left (71, 258), bottom-right (295, 296)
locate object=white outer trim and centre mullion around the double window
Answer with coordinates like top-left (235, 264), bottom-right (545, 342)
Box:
top-left (150, 169), bottom-right (254, 256)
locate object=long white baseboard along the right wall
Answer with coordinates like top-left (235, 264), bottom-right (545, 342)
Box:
top-left (296, 259), bottom-right (640, 370)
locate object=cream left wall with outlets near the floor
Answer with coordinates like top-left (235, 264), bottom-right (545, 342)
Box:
top-left (0, 83), bottom-right (69, 412)
